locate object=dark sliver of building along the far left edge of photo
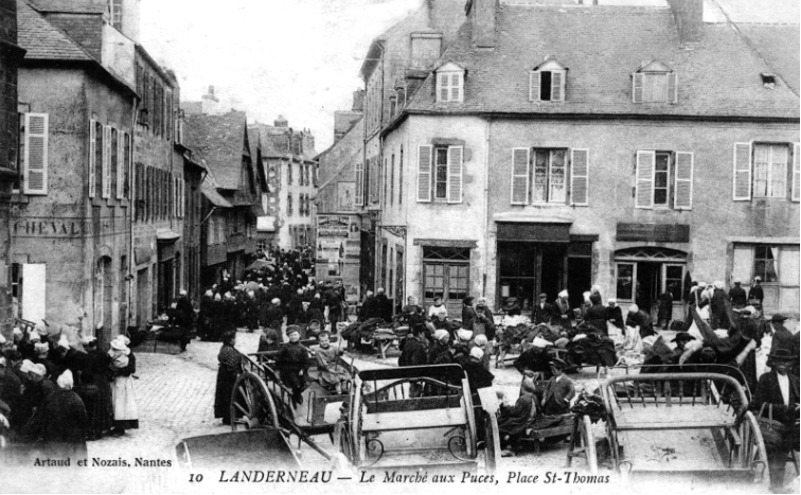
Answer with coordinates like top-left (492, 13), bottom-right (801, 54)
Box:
top-left (0, 0), bottom-right (25, 336)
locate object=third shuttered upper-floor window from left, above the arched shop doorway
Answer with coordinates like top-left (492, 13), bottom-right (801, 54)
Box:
top-left (635, 150), bottom-right (694, 210)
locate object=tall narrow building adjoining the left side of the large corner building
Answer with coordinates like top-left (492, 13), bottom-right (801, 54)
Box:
top-left (354, 0), bottom-right (465, 301)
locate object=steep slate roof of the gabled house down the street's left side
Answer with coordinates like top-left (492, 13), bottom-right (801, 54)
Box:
top-left (184, 111), bottom-right (250, 190)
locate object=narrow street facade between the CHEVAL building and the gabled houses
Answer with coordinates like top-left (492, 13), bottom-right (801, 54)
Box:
top-left (127, 45), bottom-right (185, 328)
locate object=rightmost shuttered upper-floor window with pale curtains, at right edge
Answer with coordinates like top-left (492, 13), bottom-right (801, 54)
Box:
top-left (732, 143), bottom-right (801, 201)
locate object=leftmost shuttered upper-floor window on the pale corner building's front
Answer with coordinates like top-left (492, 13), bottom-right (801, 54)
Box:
top-left (417, 145), bottom-right (464, 203)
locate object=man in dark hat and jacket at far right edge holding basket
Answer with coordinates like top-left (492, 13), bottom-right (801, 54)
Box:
top-left (751, 349), bottom-right (799, 493)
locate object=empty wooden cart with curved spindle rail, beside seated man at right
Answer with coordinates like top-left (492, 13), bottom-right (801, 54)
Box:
top-left (568, 372), bottom-right (768, 489)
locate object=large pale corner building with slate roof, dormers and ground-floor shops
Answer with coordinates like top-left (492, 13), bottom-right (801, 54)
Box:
top-left (380, 0), bottom-right (800, 316)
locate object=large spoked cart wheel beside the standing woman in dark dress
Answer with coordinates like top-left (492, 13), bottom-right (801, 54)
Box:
top-left (231, 371), bottom-right (278, 431)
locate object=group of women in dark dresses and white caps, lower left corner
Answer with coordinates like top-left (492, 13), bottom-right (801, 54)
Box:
top-left (0, 321), bottom-right (139, 458)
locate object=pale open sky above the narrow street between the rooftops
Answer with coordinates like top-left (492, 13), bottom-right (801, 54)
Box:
top-left (140, 0), bottom-right (422, 151)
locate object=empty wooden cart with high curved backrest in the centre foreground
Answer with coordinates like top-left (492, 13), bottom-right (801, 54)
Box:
top-left (335, 364), bottom-right (500, 472)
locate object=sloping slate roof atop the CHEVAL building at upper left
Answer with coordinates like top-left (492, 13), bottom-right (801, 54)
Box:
top-left (17, 0), bottom-right (94, 61)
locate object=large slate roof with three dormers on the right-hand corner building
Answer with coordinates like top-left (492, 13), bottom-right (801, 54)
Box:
top-left (407, 4), bottom-right (799, 118)
